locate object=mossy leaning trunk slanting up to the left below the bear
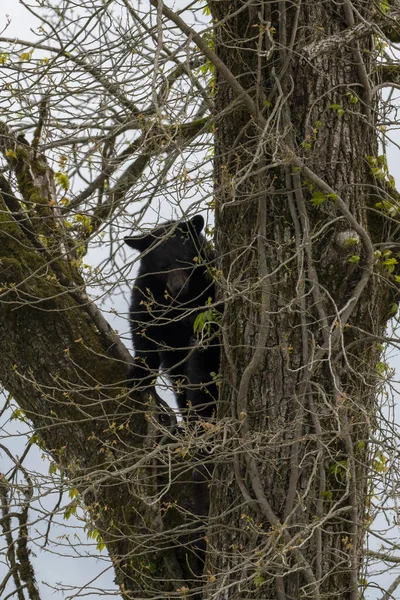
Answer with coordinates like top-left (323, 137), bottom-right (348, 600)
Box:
top-left (0, 126), bottom-right (198, 597)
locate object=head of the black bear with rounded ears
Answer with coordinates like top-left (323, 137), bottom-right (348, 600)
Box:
top-left (124, 215), bottom-right (205, 298)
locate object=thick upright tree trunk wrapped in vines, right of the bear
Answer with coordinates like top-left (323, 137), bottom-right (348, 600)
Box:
top-left (206, 1), bottom-right (395, 600)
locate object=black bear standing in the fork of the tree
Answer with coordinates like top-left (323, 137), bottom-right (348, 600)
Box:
top-left (124, 215), bottom-right (219, 418)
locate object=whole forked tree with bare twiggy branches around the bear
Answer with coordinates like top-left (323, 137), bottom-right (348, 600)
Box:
top-left (0, 0), bottom-right (400, 600)
